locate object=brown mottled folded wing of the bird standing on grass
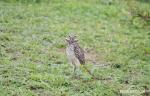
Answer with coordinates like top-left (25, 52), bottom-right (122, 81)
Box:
top-left (74, 45), bottom-right (85, 64)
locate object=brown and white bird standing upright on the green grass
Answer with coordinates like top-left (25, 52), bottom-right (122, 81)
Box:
top-left (66, 35), bottom-right (85, 75)
